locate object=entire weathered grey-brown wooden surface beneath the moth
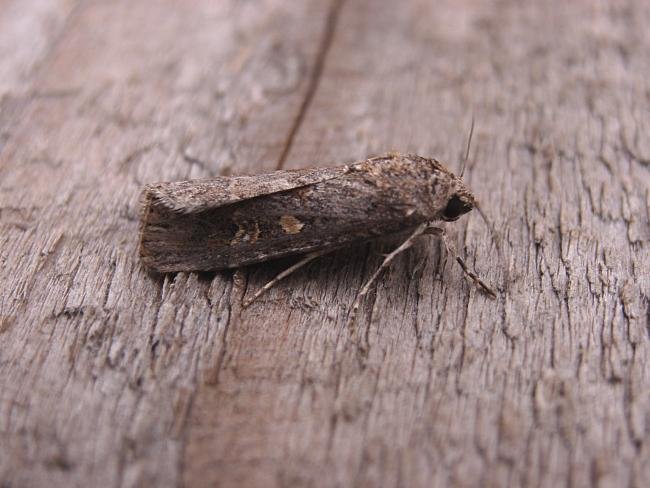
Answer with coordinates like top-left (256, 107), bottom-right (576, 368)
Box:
top-left (0, 0), bottom-right (650, 487)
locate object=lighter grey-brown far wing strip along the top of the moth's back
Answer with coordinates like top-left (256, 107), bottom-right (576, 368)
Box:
top-left (144, 166), bottom-right (348, 214)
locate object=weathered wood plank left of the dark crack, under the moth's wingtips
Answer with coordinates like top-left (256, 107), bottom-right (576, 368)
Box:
top-left (0, 1), bottom-right (340, 486)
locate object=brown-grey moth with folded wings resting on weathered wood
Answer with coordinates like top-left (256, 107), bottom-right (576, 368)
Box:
top-left (139, 153), bottom-right (495, 310)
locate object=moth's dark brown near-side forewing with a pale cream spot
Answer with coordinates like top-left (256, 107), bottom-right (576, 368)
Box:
top-left (140, 162), bottom-right (420, 272)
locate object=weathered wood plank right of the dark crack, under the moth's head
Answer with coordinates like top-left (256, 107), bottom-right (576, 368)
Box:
top-left (185, 1), bottom-right (650, 486)
